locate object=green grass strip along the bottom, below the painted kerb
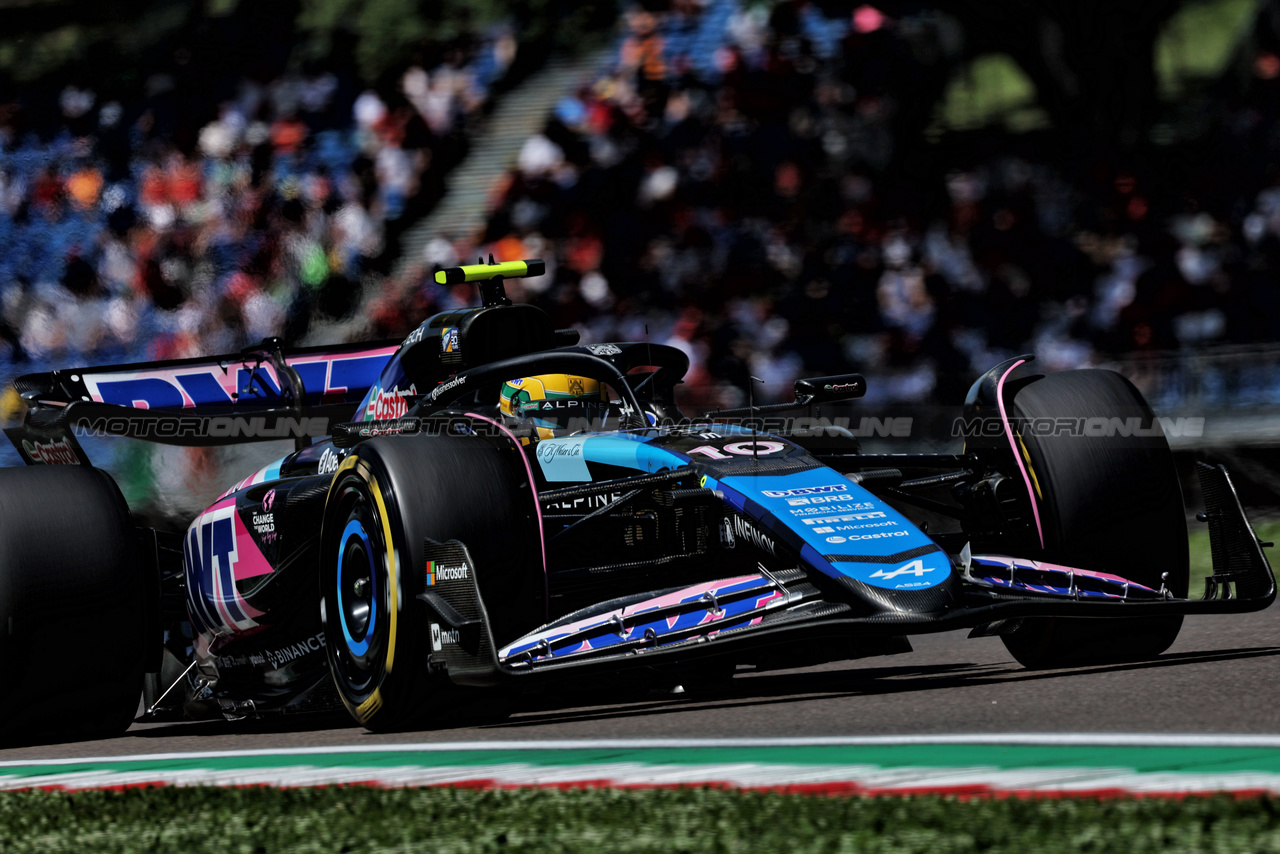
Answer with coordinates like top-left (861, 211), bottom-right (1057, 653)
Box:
top-left (0, 787), bottom-right (1280, 854)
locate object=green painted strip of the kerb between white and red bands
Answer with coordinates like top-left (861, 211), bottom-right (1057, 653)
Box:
top-left (0, 744), bottom-right (1280, 777)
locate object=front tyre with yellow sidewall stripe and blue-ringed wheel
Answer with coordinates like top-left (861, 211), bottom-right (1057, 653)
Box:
top-left (320, 435), bottom-right (543, 731)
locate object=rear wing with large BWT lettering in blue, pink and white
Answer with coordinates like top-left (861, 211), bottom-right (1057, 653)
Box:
top-left (5, 338), bottom-right (399, 465)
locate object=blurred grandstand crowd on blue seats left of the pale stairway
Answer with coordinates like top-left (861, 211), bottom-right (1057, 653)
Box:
top-left (0, 28), bottom-right (516, 425)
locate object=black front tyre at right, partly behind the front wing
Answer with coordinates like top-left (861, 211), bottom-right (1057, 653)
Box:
top-left (1002, 370), bottom-right (1189, 667)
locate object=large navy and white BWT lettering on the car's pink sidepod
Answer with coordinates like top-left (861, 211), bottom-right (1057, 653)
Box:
top-left (182, 503), bottom-right (259, 631)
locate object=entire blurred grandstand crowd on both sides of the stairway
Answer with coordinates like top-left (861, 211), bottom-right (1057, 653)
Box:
top-left (0, 0), bottom-right (1280, 414)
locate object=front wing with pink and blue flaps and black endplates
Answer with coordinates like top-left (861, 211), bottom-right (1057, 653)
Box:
top-left (421, 463), bottom-right (1276, 684)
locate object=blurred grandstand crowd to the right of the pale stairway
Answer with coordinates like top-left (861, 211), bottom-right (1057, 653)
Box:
top-left (473, 0), bottom-right (1280, 403)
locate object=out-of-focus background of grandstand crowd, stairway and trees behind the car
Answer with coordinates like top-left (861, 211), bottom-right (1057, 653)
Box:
top-left (0, 0), bottom-right (1280, 515)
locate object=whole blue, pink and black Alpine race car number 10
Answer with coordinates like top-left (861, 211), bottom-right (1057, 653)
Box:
top-left (0, 259), bottom-right (1275, 740)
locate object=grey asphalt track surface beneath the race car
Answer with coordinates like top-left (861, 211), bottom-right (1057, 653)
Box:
top-left (0, 606), bottom-right (1280, 761)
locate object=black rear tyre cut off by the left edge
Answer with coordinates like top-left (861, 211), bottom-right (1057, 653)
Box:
top-left (0, 466), bottom-right (145, 744)
